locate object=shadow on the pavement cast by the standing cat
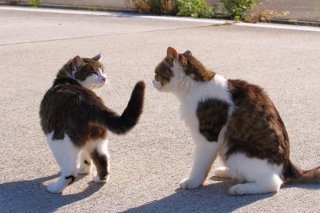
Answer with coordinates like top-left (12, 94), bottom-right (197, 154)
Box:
top-left (0, 174), bottom-right (103, 213)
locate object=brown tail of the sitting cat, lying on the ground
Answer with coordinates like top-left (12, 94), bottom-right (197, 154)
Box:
top-left (284, 161), bottom-right (320, 183)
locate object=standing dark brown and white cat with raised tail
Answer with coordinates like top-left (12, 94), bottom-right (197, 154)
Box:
top-left (40, 54), bottom-right (145, 193)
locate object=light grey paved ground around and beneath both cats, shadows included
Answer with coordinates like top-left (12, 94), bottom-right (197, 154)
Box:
top-left (0, 7), bottom-right (320, 213)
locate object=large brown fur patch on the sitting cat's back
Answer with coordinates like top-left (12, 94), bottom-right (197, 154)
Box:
top-left (226, 80), bottom-right (289, 163)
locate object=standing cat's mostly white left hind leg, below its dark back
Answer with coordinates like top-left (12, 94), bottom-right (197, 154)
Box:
top-left (47, 133), bottom-right (79, 193)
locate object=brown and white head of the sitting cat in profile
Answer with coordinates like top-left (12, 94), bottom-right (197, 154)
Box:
top-left (152, 47), bottom-right (215, 92)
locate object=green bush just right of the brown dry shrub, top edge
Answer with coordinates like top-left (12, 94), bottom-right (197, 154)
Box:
top-left (177, 0), bottom-right (215, 18)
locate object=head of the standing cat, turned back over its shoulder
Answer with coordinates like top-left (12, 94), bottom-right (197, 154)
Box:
top-left (57, 54), bottom-right (107, 90)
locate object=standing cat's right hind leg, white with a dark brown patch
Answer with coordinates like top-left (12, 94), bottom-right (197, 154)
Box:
top-left (90, 139), bottom-right (110, 182)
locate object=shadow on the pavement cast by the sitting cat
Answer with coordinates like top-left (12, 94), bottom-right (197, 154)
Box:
top-left (125, 181), bottom-right (274, 213)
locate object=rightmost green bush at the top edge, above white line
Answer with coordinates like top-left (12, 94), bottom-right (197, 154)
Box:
top-left (223, 0), bottom-right (256, 20)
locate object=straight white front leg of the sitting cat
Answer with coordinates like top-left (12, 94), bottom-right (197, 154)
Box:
top-left (180, 140), bottom-right (218, 189)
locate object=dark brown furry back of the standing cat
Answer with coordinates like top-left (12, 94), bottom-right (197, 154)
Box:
top-left (40, 80), bottom-right (104, 136)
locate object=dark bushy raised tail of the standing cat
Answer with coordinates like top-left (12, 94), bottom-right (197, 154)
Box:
top-left (99, 81), bottom-right (145, 135)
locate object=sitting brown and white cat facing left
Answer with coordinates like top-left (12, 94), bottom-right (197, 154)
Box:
top-left (153, 47), bottom-right (320, 195)
